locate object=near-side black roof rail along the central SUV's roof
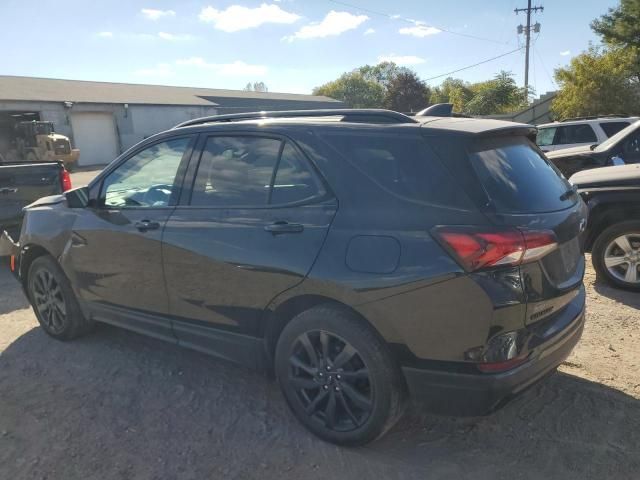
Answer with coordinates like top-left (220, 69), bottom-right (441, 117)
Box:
top-left (173, 108), bottom-right (419, 128)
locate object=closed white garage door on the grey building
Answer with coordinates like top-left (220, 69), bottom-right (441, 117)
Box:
top-left (71, 112), bottom-right (118, 166)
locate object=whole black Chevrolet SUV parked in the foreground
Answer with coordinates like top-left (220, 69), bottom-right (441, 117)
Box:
top-left (5, 110), bottom-right (587, 445)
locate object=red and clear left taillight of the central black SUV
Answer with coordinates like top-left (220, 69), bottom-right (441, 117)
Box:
top-left (431, 226), bottom-right (558, 272)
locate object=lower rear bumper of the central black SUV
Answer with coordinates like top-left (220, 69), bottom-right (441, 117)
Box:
top-left (402, 291), bottom-right (585, 416)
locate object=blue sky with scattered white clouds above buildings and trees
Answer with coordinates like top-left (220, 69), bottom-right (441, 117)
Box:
top-left (0, 0), bottom-right (618, 94)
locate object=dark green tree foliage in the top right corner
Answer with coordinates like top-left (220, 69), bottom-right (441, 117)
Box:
top-left (591, 0), bottom-right (640, 79)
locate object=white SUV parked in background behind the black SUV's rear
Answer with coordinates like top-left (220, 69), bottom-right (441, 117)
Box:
top-left (536, 117), bottom-right (639, 152)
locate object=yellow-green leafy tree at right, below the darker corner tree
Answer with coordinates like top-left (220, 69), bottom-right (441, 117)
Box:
top-left (552, 46), bottom-right (640, 118)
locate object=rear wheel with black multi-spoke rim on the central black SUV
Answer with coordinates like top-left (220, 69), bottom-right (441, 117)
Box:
top-left (275, 304), bottom-right (406, 446)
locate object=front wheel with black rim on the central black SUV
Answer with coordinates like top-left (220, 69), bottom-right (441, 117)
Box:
top-left (27, 255), bottom-right (93, 340)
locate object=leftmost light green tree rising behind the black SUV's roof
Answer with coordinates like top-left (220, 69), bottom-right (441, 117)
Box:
top-left (313, 71), bottom-right (385, 108)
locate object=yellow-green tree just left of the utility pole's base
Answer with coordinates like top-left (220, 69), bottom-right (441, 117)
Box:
top-left (464, 70), bottom-right (527, 115)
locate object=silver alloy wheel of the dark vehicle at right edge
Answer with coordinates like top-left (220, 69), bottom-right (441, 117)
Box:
top-left (591, 220), bottom-right (640, 291)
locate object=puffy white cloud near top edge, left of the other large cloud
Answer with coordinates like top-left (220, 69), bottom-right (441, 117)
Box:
top-left (200, 3), bottom-right (300, 32)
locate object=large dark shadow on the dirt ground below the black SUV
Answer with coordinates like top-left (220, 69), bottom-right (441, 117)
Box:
top-left (0, 326), bottom-right (640, 480)
